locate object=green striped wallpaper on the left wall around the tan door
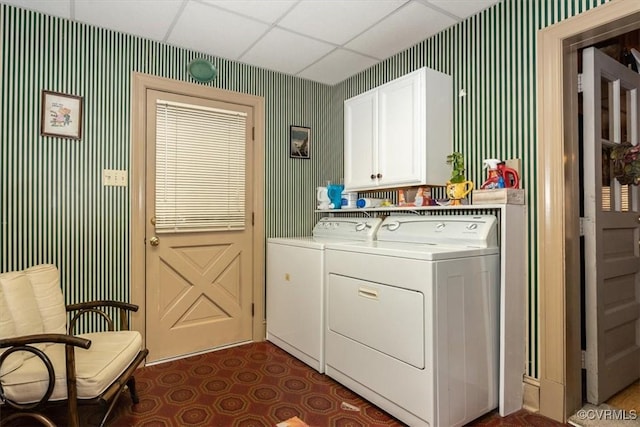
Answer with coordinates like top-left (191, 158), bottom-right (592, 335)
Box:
top-left (0, 4), bottom-right (332, 302)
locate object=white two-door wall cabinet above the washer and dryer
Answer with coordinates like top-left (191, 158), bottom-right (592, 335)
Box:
top-left (344, 68), bottom-right (453, 190)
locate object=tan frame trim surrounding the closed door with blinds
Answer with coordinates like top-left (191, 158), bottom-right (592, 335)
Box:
top-left (129, 72), bottom-right (266, 356)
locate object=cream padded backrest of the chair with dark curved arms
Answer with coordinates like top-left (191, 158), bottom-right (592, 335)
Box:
top-left (0, 264), bottom-right (67, 376)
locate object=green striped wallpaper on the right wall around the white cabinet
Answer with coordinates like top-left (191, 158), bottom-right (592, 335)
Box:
top-left (333, 0), bottom-right (608, 378)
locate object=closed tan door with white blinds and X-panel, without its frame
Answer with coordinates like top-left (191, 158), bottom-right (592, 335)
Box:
top-left (145, 90), bottom-right (254, 362)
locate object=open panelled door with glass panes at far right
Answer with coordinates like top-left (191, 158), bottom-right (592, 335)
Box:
top-left (583, 48), bottom-right (640, 404)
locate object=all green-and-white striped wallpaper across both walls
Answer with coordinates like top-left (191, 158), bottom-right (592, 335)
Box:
top-left (0, 0), bottom-right (606, 377)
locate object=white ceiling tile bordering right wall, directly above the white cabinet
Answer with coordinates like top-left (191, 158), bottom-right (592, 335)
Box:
top-left (345, 1), bottom-right (457, 59)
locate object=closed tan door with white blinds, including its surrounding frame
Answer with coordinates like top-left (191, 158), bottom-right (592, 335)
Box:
top-left (130, 73), bottom-right (265, 362)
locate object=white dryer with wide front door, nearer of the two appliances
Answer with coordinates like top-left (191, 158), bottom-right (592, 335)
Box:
top-left (325, 215), bottom-right (500, 427)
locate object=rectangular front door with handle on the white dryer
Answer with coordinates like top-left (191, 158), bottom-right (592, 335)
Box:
top-left (327, 274), bottom-right (425, 369)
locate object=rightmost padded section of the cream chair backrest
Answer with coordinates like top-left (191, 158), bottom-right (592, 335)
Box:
top-left (24, 264), bottom-right (67, 334)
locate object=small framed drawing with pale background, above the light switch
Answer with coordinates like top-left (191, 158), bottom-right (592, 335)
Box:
top-left (40, 90), bottom-right (82, 139)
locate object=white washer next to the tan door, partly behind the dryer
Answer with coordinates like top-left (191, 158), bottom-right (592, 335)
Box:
top-left (266, 217), bottom-right (382, 372)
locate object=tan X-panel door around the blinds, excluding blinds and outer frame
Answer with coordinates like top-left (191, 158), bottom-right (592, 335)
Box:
top-left (146, 90), bottom-right (253, 362)
